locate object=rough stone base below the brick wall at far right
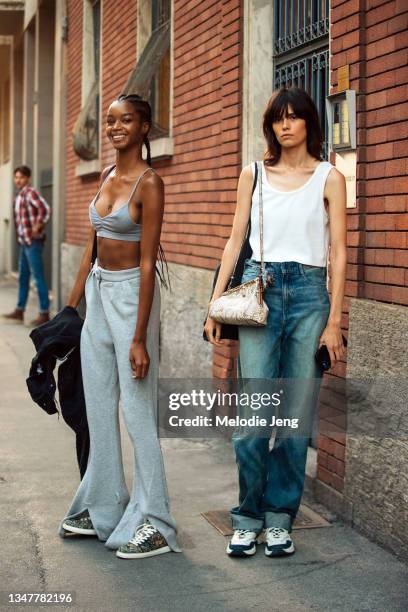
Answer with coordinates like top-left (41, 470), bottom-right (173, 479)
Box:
top-left (313, 299), bottom-right (408, 559)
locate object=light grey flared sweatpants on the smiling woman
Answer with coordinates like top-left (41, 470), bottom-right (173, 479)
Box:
top-left (59, 263), bottom-right (180, 552)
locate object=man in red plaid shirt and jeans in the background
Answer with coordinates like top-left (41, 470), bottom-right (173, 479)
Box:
top-left (3, 166), bottom-right (51, 327)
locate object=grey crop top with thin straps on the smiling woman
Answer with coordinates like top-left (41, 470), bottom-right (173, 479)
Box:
top-left (89, 166), bottom-right (154, 242)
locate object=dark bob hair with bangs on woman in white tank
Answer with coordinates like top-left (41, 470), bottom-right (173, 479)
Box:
top-left (262, 87), bottom-right (323, 166)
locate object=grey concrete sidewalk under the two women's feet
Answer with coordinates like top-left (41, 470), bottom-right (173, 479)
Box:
top-left (0, 281), bottom-right (408, 612)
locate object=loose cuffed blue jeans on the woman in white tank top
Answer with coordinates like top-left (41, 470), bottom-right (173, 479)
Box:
top-left (231, 259), bottom-right (330, 532)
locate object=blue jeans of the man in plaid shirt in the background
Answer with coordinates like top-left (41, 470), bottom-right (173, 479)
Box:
top-left (17, 240), bottom-right (50, 312)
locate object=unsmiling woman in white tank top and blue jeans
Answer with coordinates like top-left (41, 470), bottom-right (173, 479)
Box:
top-left (205, 87), bottom-right (347, 556)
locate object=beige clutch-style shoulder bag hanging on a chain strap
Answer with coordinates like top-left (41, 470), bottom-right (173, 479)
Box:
top-left (208, 162), bottom-right (269, 326)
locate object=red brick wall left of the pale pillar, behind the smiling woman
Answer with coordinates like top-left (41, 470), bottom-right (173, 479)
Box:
top-left (66, 0), bottom-right (241, 262)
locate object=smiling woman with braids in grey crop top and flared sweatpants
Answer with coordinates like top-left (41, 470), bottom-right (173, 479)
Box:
top-left (59, 95), bottom-right (180, 559)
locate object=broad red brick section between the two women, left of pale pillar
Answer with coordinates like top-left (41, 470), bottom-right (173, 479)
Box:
top-left (162, 0), bottom-right (241, 269)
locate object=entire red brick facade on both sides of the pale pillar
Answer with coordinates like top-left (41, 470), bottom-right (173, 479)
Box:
top-left (66, 0), bottom-right (408, 500)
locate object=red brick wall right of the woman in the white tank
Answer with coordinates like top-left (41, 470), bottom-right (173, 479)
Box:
top-left (317, 0), bottom-right (408, 491)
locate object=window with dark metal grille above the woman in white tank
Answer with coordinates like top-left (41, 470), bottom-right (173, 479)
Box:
top-left (273, 0), bottom-right (330, 159)
